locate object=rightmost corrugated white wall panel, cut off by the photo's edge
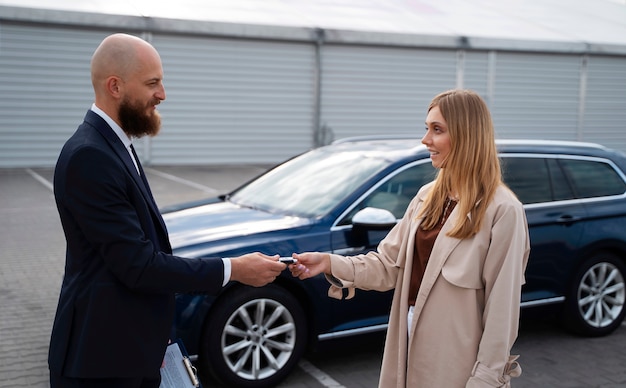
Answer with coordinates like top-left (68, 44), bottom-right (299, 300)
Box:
top-left (582, 56), bottom-right (626, 152)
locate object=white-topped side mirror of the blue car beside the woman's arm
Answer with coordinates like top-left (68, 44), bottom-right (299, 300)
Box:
top-left (352, 207), bottom-right (396, 247)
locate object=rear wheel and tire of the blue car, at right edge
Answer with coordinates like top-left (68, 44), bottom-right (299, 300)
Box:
top-left (563, 252), bottom-right (626, 337)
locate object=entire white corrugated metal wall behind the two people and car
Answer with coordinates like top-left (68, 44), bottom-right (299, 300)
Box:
top-left (0, 22), bottom-right (626, 167)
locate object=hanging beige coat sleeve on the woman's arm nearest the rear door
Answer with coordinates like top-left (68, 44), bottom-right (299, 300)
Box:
top-left (466, 200), bottom-right (530, 388)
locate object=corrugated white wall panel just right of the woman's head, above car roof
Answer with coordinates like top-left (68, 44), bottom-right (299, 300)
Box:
top-left (491, 52), bottom-right (581, 140)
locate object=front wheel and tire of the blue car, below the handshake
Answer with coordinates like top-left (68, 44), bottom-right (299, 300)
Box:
top-left (199, 284), bottom-right (308, 388)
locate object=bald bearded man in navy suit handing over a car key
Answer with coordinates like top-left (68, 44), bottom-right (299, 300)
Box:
top-left (48, 34), bottom-right (286, 388)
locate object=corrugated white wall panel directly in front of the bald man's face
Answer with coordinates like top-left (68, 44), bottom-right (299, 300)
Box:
top-left (146, 35), bottom-right (314, 164)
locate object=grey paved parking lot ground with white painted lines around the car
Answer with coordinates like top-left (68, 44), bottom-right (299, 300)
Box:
top-left (0, 165), bottom-right (626, 388)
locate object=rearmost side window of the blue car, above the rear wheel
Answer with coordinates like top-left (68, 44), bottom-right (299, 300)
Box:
top-left (559, 159), bottom-right (626, 198)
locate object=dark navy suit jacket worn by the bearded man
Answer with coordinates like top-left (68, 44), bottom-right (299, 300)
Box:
top-left (48, 111), bottom-right (224, 378)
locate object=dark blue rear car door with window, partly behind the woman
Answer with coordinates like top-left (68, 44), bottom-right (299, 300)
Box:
top-left (502, 154), bottom-right (587, 307)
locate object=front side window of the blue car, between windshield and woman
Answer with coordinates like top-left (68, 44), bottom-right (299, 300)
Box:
top-left (338, 163), bottom-right (436, 225)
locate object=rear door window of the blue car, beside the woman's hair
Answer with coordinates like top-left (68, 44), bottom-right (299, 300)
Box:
top-left (501, 157), bottom-right (552, 204)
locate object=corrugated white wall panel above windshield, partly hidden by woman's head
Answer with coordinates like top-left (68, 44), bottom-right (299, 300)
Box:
top-left (321, 45), bottom-right (456, 138)
